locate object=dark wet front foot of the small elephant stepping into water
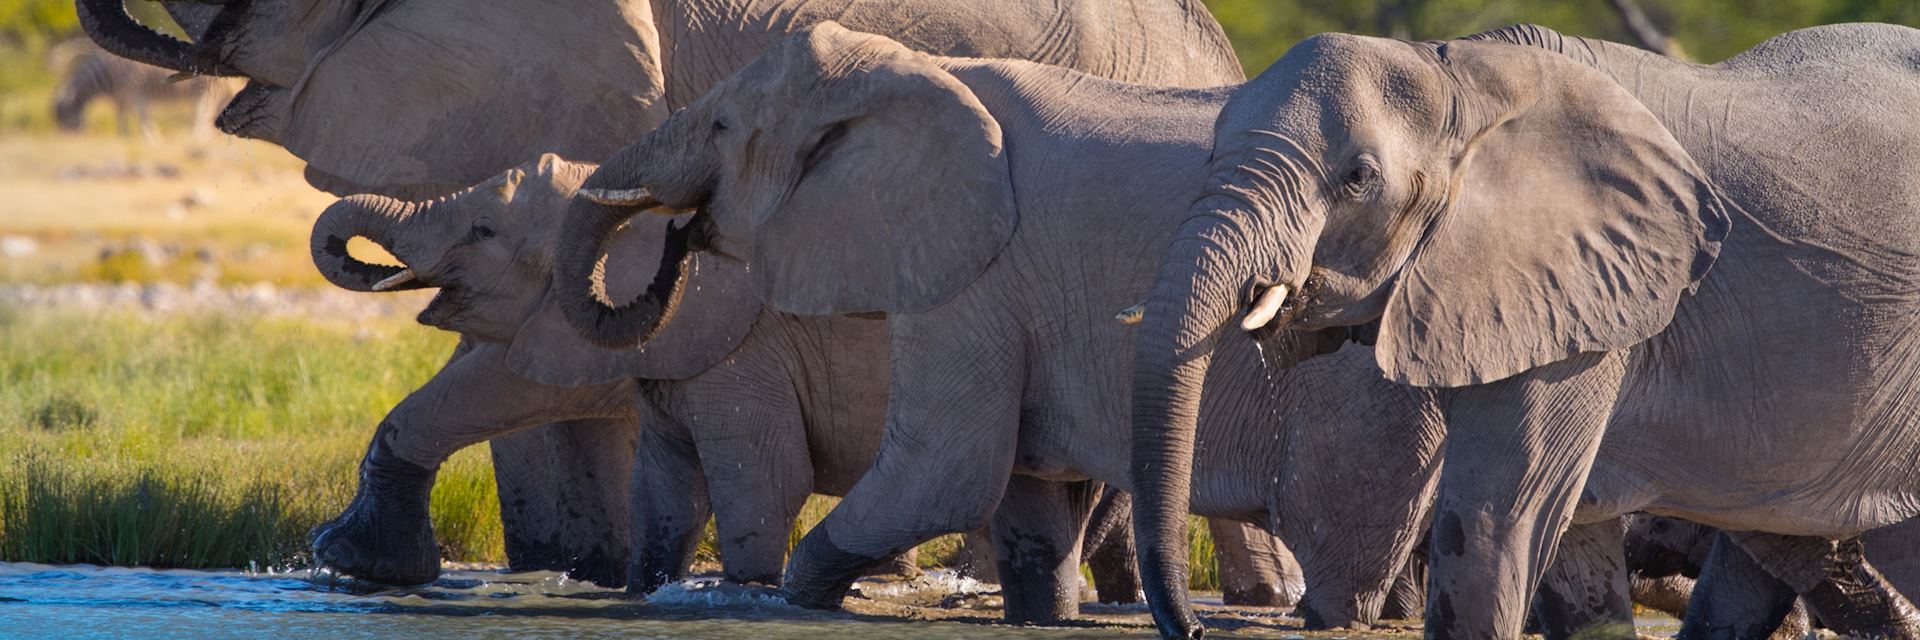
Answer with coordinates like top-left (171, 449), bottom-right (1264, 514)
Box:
top-left (311, 436), bottom-right (440, 584)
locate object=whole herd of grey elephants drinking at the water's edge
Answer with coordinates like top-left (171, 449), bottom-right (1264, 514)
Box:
top-left (77, 0), bottom-right (1920, 638)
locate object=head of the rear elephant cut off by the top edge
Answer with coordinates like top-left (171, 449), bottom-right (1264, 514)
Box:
top-left (75, 0), bottom-right (666, 198)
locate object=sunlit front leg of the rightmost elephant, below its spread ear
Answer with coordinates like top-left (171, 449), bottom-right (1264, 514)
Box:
top-left (1427, 354), bottom-right (1624, 640)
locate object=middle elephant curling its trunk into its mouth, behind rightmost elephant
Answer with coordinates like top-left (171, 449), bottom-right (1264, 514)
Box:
top-left (547, 23), bottom-right (1442, 627)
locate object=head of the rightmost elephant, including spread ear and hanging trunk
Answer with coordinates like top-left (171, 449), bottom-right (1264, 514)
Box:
top-left (1131, 35), bottom-right (1728, 636)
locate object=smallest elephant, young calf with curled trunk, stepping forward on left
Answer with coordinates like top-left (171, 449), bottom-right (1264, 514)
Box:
top-left (311, 154), bottom-right (1175, 613)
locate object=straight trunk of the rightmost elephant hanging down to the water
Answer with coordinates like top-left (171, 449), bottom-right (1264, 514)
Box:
top-left (1131, 206), bottom-right (1248, 638)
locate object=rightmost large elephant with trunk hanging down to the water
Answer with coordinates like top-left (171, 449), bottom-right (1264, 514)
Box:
top-left (1131, 25), bottom-right (1920, 638)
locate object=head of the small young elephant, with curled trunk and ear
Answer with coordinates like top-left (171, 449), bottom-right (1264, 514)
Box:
top-left (311, 154), bottom-right (760, 386)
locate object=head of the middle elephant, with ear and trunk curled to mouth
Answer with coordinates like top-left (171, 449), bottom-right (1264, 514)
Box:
top-left (553, 23), bottom-right (1016, 346)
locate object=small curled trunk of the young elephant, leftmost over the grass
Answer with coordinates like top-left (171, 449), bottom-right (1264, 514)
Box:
top-left (309, 196), bottom-right (432, 292)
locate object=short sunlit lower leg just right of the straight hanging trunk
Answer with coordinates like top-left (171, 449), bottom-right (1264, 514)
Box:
top-left (1206, 519), bottom-right (1302, 607)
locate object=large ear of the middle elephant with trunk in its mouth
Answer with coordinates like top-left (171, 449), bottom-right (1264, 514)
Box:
top-left (753, 23), bottom-right (1016, 315)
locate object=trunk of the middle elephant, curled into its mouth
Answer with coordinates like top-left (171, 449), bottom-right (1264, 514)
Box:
top-left (553, 190), bottom-right (699, 348)
